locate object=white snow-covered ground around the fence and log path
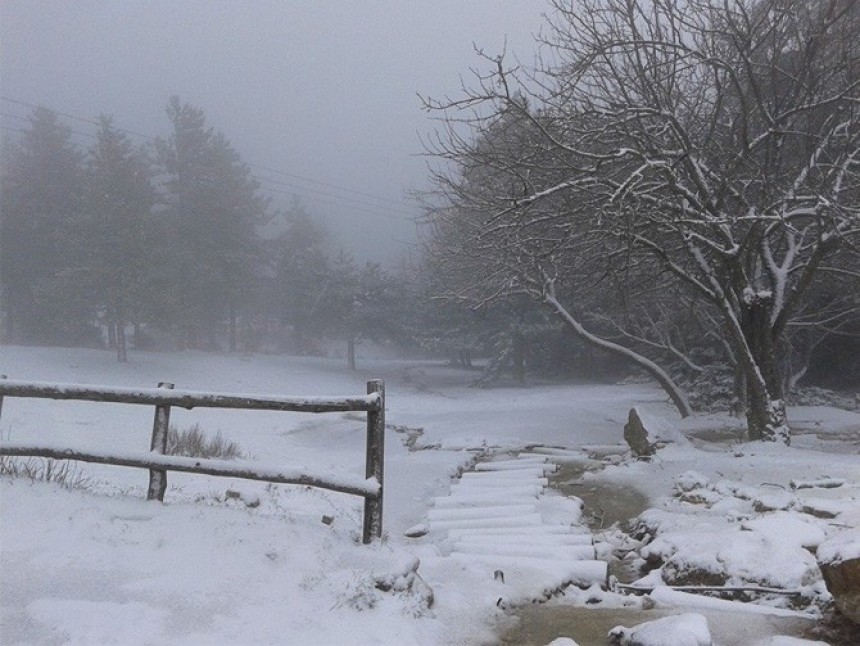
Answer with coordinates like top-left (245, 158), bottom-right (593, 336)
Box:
top-left (0, 347), bottom-right (860, 644)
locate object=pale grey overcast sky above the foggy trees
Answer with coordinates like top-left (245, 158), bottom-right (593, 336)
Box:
top-left (0, 0), bottom-right (544, 260)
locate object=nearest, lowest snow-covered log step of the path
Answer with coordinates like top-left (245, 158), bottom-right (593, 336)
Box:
top-left (448, 552), bottom-right (609, 593)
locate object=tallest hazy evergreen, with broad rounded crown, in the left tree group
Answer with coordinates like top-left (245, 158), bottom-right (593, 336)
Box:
top-left (157, 97), bottom-right (267, 349)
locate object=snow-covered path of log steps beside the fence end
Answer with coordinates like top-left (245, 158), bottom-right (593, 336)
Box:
top-left (414, 453), bottom-right (608, 607)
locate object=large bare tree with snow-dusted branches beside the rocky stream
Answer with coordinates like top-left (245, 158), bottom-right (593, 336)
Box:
top-left (428, 0), bottom-right (860, 442)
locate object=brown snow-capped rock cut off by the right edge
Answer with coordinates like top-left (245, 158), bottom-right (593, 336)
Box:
top-left (816, 527), bottom-right (860, 624)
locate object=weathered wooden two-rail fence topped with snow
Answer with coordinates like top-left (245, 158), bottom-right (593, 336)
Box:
top-left (0, 378), bottom-right (385, 543)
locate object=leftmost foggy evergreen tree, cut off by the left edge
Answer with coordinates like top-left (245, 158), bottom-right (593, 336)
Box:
top-left (0, 108), bottom-right (88, 343)
